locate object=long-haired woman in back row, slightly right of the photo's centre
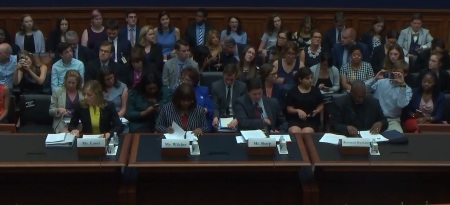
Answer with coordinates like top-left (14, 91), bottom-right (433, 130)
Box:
top-left (258, 13), bottom-right (283, 62)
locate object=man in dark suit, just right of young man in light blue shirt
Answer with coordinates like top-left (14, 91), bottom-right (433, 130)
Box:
top-left (84, 41), bottom-right (120, 82)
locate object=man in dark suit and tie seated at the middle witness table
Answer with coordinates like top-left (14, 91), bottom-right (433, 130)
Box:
top-left (233, 78), bottom-right (287, 133)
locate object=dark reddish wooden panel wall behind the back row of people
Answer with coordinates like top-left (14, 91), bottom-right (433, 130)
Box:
top-left (0, 7), bottom-right (450, 50)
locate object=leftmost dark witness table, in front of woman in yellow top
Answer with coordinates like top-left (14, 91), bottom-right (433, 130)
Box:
top-left (0, 134), bottom-right (132, 204)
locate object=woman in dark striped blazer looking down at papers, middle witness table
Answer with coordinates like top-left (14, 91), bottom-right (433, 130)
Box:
top-left (156, 83), bottom-right (209, 136)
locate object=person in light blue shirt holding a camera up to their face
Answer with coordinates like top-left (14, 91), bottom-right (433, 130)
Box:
top-left (366, 61), bottom-right (412, 132)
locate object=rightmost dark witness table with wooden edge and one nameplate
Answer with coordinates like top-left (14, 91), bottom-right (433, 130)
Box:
top-left (304, 134), bottom-right (450, 204)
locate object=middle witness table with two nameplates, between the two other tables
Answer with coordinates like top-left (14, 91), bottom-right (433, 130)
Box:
top-left (128, 134), bottom-right (311, 203)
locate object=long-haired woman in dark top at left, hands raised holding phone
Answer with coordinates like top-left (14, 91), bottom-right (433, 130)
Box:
top-left (13, 51), bottom-right (49, 93)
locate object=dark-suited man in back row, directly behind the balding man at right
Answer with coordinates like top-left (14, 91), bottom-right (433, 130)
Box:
top-left (322, 12), bottom-right (346, 53)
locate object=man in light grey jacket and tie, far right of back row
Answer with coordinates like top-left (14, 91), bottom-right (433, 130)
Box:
top-left (397, 13), bottom-right (433, 56)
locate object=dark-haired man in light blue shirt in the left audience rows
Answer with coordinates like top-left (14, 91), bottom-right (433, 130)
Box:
top-left (51, 42), bottom-right (84, 90)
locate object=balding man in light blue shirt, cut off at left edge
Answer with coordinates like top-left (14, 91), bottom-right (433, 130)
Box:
top-left (0, 43), bottom-right (17, 89)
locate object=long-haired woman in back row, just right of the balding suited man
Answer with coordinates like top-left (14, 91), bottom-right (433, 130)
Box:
top-left (360, 16), bottom-right (385, 56)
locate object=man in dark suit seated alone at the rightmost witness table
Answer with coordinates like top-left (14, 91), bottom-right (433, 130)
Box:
top-left (331, 80), bottom-right (388, 136)
